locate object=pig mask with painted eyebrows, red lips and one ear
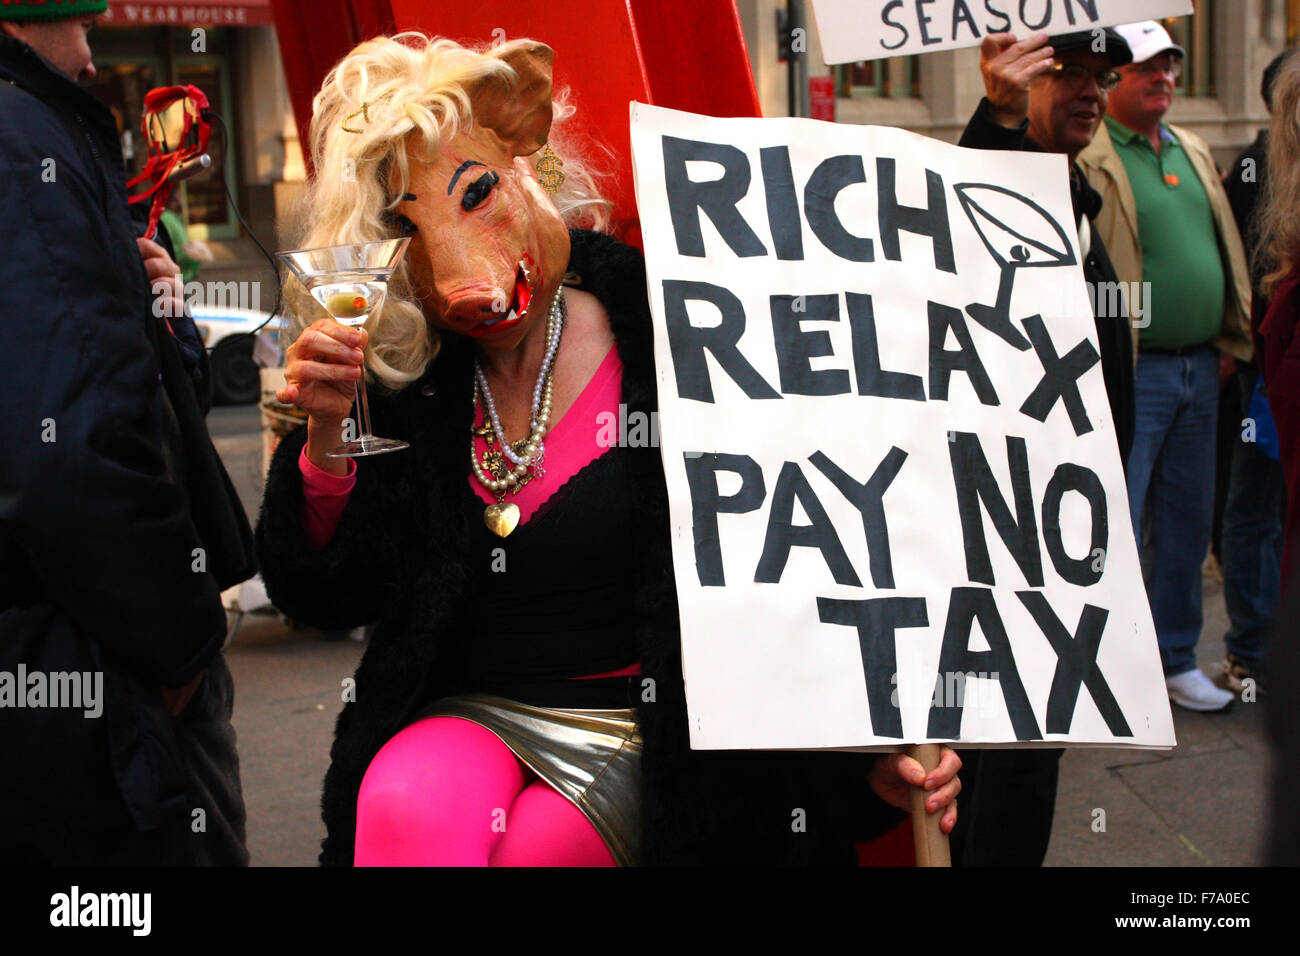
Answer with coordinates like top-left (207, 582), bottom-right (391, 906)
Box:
top-left (393, 42), bottom-right (569, 350)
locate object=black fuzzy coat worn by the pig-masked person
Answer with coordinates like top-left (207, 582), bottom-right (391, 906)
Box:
top-left (256, 230), bottom-right (902, 865)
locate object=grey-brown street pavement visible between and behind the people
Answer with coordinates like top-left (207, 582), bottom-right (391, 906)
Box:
top-left (208, 406), bottom-right (1270, 866)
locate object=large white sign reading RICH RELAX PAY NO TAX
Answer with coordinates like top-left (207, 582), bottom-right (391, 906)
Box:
top-left (632, 103), bottom-right (1174, 749)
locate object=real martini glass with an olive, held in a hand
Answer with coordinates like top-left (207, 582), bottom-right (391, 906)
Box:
top-left (276, 237), bottom-right (411, 458)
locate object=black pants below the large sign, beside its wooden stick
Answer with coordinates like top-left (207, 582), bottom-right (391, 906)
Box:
top-left (949, 749), bottom-right (1065, 866)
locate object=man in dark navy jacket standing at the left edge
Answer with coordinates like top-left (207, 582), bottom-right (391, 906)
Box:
top-left (0, 0), bottom-right (254, 865)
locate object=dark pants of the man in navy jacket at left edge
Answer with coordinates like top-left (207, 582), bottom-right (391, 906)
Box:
top-left (0, 654), bottom-right (248, 866)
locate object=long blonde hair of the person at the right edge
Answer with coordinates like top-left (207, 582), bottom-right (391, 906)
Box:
top-left (1258, 56), bottom-right (1300, 295)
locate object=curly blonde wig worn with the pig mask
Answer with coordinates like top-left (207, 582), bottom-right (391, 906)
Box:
top-left (293, 33), bottom-right (610, 390)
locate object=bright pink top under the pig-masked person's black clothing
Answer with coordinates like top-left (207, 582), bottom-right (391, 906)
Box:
top-left (298, 349), bottom-right (641, 679)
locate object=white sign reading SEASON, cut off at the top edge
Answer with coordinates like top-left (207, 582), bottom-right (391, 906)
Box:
top-left (813, 0), bottom-right (1192, 64)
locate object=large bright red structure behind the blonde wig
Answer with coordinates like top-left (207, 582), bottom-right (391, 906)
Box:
top-left (273, 0), bottom-right (761, 238)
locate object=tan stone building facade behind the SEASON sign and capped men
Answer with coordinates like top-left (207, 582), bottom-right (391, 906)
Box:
top-left (737, 0), bottom-right (1300, 166)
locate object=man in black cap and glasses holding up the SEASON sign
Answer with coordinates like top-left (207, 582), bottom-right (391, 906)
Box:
top-left (953, 30), bottom-right (1136, 866)
